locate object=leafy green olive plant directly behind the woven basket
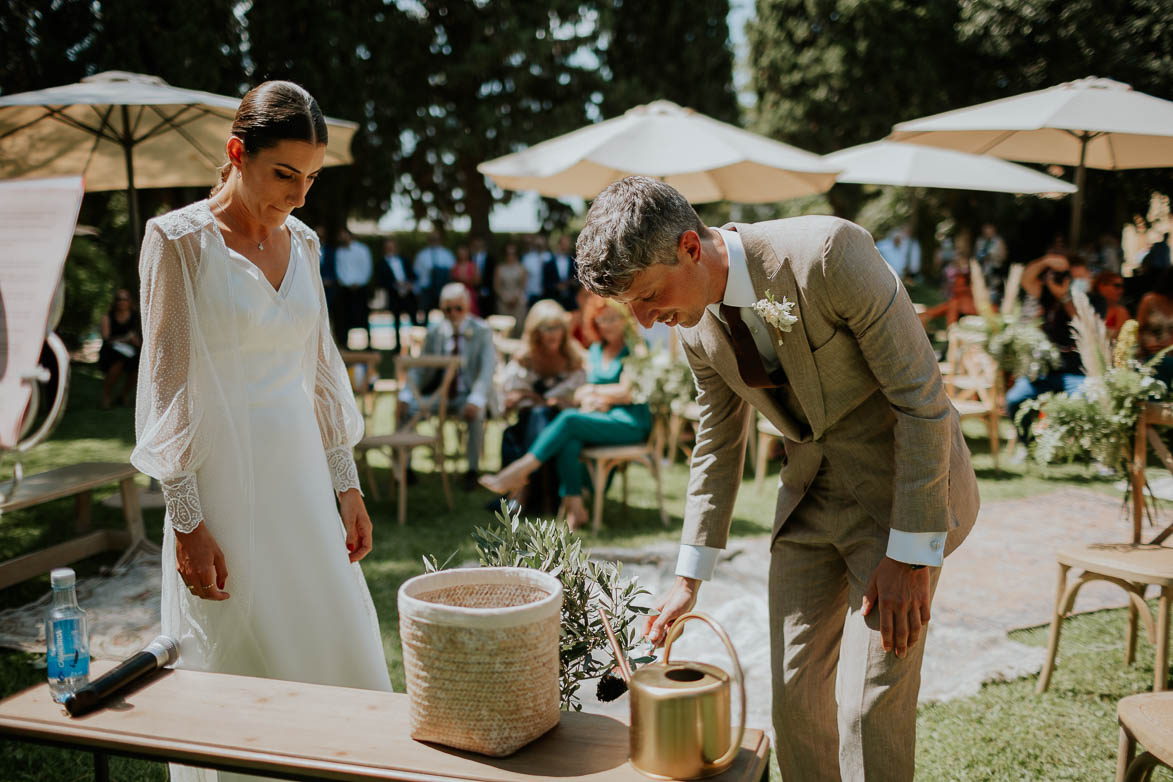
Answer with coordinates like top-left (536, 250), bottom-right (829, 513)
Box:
top-left (423, 502), bottom-right (655, 712)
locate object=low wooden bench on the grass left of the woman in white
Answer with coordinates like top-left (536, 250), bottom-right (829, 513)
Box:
top-left (0, 462), bottom-right (154, 589)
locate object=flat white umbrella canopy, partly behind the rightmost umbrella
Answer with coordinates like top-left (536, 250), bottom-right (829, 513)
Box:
top-left (823, 141), bottom-right (1076, 195)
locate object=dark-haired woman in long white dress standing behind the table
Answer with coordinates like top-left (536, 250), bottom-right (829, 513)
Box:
top-left (131, 81), bottom-right (391, 781)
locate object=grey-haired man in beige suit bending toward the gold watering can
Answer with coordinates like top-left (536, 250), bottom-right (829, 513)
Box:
top-left (577, 177), bottom-right (978, 782)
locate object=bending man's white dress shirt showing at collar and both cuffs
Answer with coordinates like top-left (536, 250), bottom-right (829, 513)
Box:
top-left (676, 229), bottom-right (945, 582)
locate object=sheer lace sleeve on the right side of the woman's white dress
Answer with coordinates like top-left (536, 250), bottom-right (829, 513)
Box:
top-left (299, 230), bottom-right (362, 492)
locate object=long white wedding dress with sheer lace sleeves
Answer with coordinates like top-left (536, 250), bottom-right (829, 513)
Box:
top-left (131, 202), bottom-right (391, 782)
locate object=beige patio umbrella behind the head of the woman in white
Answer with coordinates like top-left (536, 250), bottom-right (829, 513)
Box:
top-left (0, 70), bottom-right (358, 244)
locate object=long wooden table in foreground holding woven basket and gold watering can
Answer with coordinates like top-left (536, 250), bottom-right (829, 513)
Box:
top-left (0, 662), bottom-right (769, 782)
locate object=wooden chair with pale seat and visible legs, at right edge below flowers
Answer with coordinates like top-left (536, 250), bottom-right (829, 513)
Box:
top-left (1036, 403), bottom-right (1173, 693)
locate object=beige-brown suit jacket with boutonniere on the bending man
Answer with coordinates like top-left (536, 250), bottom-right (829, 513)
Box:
top-left (680, 216), bottom-right (978, 553)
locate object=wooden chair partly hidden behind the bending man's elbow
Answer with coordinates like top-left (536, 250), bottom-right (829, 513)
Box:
top-left (941, 325), bottom-right (1002, 472)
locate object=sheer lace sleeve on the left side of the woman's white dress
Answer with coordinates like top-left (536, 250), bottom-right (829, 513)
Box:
top-left (130, 222), bottom-right (208, 532)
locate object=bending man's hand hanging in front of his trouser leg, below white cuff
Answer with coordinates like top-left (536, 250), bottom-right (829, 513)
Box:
top-left (863, 557), bottom-right (933, 657)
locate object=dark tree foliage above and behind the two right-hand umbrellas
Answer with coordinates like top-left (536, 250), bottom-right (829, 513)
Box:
top-left (747, 0), bottom-right (1173, 259)
